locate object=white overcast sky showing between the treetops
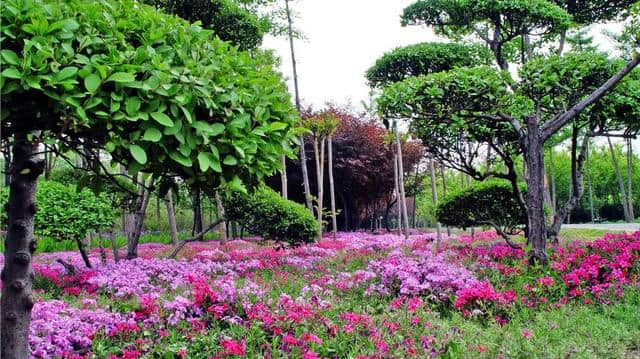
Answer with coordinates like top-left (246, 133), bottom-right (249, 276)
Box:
top-left (263, 0), bottom-right (618, 112)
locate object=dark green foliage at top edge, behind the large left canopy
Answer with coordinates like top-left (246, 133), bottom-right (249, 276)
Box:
top-left (144, 0), bottom-right (268, 50)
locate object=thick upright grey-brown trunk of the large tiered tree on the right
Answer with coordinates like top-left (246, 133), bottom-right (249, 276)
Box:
top-left (524, 116), bottom-right (547, 264)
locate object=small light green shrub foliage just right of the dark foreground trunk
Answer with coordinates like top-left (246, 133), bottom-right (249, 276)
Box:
top-left (0, 181), bottom-right (118, 241)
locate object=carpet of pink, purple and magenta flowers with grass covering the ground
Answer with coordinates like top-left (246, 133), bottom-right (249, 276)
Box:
top-left (10, 232), bottom-right (640, 358)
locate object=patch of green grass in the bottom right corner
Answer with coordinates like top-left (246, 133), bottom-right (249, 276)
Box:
top-left (440, 290), bottom-right (640, 358)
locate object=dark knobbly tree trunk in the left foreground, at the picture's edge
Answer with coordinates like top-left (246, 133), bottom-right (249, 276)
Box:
top-left (0, 133), bottom-right (44, 359)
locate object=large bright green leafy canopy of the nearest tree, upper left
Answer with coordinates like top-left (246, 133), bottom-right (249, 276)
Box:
top-left (0, 0), bottom-right (297, 194)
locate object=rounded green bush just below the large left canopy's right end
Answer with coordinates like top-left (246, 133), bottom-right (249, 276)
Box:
top-left (224, 188), bottom-right (318, 246)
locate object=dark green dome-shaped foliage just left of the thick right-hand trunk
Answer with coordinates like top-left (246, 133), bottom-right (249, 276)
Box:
top-left (436, 181), bottom-right (527, 233)
